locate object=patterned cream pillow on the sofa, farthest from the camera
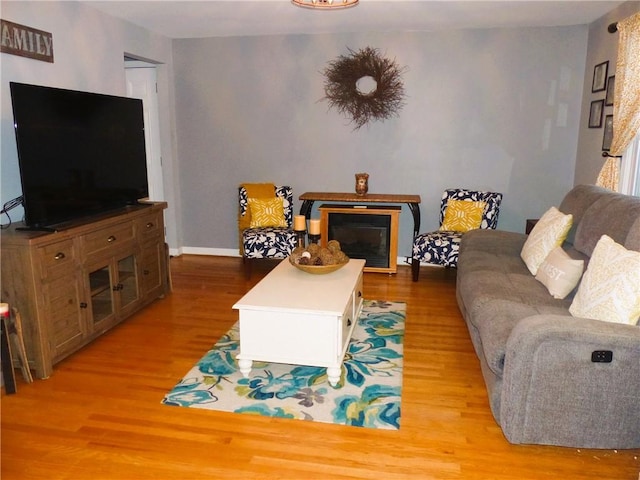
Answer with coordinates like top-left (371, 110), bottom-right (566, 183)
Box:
top-left (520, 207), bottom-right (573, 275)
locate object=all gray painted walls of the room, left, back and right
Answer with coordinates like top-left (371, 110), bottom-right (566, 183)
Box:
top-left (0, 1), bottom-right (640, 255)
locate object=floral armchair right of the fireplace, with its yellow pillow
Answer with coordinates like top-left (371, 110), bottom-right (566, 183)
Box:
top-left (411, 189), bottom-right (502, 282)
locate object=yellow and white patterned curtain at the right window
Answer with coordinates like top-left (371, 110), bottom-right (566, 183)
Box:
top-left (596, 13), bottom-right (640, 191)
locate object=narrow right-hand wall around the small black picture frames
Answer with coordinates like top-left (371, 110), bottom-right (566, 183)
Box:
top-left (575, 1), bottom-right (640, 184)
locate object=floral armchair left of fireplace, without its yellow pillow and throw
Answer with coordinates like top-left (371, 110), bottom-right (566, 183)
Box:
top-left (238, 186), bottom-right (296, 276)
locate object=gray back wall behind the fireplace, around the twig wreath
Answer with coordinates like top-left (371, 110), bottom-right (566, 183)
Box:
top-left (174, 26), bottom-right (587, 256)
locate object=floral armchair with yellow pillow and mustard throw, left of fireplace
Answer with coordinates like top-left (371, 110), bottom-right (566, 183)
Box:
top-left (238, 183), bottom-right (296, 276)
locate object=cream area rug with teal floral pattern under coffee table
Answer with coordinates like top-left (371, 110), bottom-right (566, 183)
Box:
top-left (162, 300), bottom-right (406, 429)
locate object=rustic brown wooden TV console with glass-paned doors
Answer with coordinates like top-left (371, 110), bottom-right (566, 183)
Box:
top-left (0, 202), bottom-right (169, 378)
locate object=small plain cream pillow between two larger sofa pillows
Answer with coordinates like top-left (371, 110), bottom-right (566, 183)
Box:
top-left (536, 247), bottom-right (584, 298)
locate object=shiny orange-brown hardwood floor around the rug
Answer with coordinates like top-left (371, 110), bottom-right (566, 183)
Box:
top-left (1, 255), bottom-right (640, 480)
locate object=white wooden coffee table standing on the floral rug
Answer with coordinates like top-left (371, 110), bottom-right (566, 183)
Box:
top-left (233, 259), bottom-right (365, 386)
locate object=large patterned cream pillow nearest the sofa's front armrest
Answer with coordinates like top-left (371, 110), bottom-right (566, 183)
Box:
top-left (569, 235), bottom-right (640, 325)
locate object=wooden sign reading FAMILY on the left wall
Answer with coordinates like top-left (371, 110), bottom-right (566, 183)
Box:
top-left (0, 19), bottom-right (53, 63)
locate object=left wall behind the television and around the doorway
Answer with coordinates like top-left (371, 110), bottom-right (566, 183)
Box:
top-left (0, 1), bottom-right (181, 245)
